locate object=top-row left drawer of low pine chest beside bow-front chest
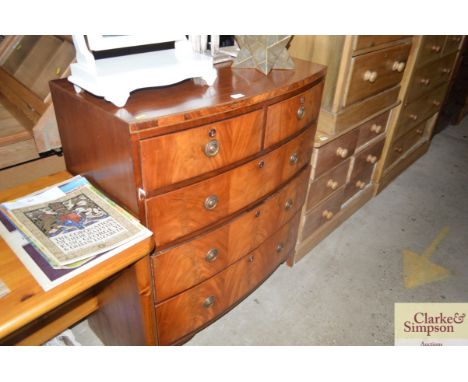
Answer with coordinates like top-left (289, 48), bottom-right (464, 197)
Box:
top-left (312, 129), bottom-right (359, 179)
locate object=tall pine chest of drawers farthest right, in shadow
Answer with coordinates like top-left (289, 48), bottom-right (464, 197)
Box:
top-left (374, 36), bottom-right (463, 193)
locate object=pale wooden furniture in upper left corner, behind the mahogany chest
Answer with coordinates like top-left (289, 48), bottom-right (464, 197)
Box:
top-left (0, 36), bottom-right (75, 169)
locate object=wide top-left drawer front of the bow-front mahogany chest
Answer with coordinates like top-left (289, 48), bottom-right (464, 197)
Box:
top-left (140, 110), bottom-right (263, 191)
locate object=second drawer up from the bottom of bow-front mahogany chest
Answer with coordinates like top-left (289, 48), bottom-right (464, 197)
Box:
top-left (151, 169), bottom-right (309, 302)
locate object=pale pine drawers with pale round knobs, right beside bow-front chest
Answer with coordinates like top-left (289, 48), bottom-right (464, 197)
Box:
top-left (289, 36), bottom-right (411, 264)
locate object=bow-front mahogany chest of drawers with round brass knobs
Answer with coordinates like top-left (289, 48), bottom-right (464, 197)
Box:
top-left (51, 60), bottom-right (325, 345)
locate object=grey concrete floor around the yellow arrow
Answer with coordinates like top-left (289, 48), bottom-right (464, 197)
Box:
top-left (72, 118), bottom-right (468, 345)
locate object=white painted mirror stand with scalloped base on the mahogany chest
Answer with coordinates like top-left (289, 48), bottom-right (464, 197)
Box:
top-left (68, 35), bottom-right (216, 107)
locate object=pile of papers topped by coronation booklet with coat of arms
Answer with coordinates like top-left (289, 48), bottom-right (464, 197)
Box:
top-left (0, 176), bottom-right (151, 291)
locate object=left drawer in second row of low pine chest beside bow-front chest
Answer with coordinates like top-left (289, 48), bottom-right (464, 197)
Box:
top-left (306, 159), bottom-right (351, 211)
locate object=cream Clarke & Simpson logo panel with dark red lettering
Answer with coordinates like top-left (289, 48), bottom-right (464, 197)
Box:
top-left (395, 303), bottom-right (468, 346)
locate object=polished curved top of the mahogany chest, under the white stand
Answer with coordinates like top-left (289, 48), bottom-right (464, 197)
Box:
top-left (51, 59), bottom-right (325, 132)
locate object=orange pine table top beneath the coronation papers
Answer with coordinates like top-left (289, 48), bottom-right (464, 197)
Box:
top-left (0, 171), bottom-right (153, 338)
